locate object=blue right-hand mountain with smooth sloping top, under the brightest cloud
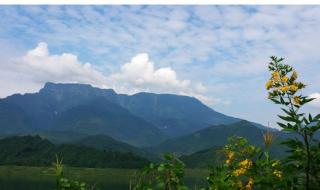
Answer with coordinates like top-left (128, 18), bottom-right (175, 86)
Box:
top-left (118, 92), bottom-right (240, 137)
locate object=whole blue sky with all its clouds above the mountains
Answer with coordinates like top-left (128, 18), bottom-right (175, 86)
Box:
top-left (0, 5), bottom-right (320, 127)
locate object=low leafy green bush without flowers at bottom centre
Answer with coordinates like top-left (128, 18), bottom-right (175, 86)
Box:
top-left (133, 154), bottom-right (188, 190)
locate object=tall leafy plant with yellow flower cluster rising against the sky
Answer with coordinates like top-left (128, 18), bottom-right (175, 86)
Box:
top-left (266, 57), bottom-right (320, 189)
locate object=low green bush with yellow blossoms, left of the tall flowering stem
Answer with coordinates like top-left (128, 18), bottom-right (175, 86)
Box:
top-left (207, 137), bottom-right (285, 190)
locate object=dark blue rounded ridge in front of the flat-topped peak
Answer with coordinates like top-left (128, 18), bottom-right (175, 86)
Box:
top-left (56, 98), bottom-right (165, 146)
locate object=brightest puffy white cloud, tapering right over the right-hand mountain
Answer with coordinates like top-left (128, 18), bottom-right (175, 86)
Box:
top-left (110, 53), bottom-right (218, 105)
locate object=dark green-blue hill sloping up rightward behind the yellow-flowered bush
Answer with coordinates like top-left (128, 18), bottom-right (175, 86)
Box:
top-left (150, 120), bottom-right (281, 155)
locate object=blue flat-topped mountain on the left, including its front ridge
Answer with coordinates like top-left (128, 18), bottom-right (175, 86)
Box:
top-left (0, 83), bottom-right (165, 146)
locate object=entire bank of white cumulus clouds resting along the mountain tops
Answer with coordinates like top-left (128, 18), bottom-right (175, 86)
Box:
top-left (0, 42), bottom-right (224, 104)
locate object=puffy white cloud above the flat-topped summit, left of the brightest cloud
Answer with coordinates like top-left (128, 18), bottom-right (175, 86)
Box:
top-left (16, 42), bottom-right (107, 86)
